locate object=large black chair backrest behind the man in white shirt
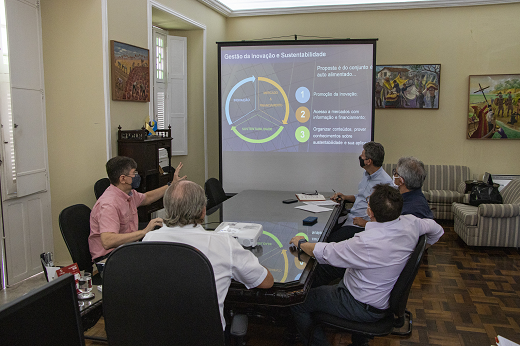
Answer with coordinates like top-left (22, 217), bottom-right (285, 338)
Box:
top-left (103, 242), bottom-right (224, 345)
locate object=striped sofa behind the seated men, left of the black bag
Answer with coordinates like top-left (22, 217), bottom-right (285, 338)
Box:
top-left (383, 163), bottom-right (471, 220)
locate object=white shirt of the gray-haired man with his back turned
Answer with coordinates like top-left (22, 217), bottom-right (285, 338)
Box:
top-left (143, 225), bottom-right (267, 329)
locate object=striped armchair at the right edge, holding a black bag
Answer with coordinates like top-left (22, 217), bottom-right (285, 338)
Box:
top-left (453, 179), bottom-right (520, 247)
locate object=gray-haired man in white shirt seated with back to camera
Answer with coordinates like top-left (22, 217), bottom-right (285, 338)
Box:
top-left (143, 180), bottom-right (274, 329)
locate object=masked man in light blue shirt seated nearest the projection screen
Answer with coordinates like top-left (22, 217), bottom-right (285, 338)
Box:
top-left (327, 142), bottom-right (392, 242)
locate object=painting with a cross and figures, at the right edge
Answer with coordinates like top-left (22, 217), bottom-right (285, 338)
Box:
top-left (466, 74), bottom-right (520, 139)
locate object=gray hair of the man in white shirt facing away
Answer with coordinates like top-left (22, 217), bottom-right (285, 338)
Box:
top-left (164, 180), bottom-right (207, 227)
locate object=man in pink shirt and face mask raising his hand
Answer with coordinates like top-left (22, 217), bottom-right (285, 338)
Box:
top-left (88, 156), bottom-right (186, 262)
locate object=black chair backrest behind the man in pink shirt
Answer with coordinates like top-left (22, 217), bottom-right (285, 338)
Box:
top-left (59, 204), bottom-right (92, 273)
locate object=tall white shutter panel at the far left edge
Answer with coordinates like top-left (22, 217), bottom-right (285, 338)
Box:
top-left (4, 0), bottom-right (47, 197)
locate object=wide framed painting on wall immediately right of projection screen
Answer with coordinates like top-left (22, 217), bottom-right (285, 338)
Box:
top-left (374, 64), bottom-right (441, 109)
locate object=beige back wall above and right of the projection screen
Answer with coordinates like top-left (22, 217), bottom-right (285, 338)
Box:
top-left (226, 3), bottom-right (520, 178)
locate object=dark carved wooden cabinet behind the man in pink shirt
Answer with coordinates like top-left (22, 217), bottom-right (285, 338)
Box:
top-left (117, 126), bottom-right (173, 222)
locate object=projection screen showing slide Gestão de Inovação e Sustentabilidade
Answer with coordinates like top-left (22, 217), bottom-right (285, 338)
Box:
top-left (218, 39), bottom-right (376, 194)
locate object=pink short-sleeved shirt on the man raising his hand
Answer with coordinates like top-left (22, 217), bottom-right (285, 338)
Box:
top-left (88, 184), bottom-right (146, 259)
